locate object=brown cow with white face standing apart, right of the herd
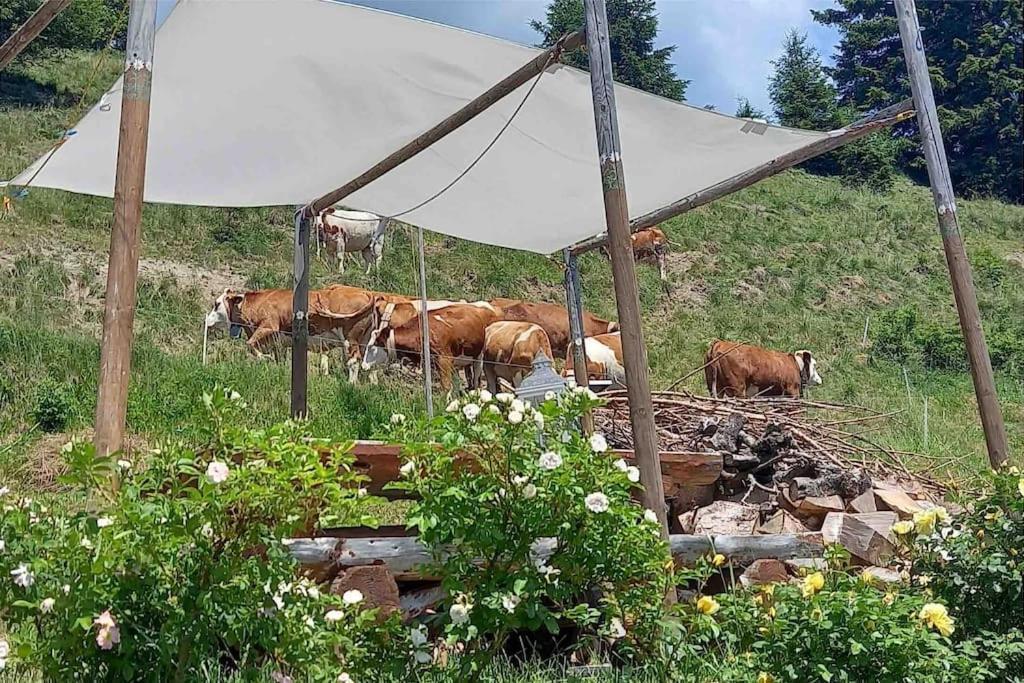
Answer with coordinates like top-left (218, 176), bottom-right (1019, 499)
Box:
top-left (705, 340), bottom-right (821, 398)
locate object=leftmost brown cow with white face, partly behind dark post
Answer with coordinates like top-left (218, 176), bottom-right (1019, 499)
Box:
top-left (206, 286), bottom-right (374, 374)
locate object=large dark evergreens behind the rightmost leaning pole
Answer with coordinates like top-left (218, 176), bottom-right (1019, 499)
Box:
top-left (813, 0), bottom-right (1024, 202)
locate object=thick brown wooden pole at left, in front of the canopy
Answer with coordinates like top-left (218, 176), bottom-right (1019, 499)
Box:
top-left (94, 0), bottom-right (157, 464)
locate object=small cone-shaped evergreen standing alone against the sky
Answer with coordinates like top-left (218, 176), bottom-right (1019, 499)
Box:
top-left (768, 31), bottom-right (837, 130)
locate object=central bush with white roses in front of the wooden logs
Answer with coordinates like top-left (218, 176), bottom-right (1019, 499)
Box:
top-left (391, 389), bottom-right (672, 666)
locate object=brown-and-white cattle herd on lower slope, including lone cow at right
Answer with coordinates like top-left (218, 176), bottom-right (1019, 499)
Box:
top-left (206, 285), bottom-right (821, 396)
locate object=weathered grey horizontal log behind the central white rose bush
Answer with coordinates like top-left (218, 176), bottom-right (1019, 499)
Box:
top-left (288, 532), bottom-right (824, 581)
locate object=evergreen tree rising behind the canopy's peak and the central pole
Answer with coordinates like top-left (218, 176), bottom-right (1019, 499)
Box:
top-left (530, 0), bottom-right (689, 101)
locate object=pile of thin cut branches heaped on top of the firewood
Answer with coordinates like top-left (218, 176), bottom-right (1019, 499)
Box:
top-left (594, 391), bottom-right (943, 498)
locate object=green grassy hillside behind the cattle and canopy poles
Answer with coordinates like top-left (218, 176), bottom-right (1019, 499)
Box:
top-left (0, 54), bottom-right (1024, 491)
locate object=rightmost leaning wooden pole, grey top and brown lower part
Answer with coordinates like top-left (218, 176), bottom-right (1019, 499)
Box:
top-left (896, 0), bottom-right (1009, 469)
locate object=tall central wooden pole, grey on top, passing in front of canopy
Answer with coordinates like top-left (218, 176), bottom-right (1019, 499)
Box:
top-left (584, 0), bottom-right (675, 548)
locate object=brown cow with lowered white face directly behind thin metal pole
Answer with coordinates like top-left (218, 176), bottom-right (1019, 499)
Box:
top-left (362, 301), bottom-right (501, 391)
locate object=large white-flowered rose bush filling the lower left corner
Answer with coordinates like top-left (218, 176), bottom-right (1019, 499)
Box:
top-left (0, 389), bottom-right (412, 681)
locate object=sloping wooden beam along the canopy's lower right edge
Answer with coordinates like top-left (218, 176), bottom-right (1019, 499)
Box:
top-left (572, 99), bottom-right (913, 256)
